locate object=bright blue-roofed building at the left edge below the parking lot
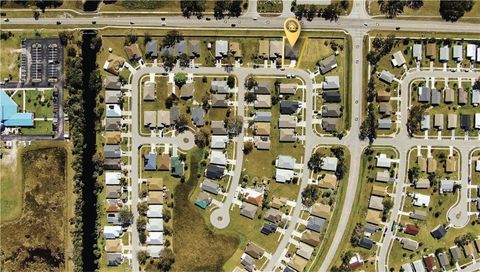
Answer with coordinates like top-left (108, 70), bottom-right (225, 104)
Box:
top-left (0, 90), bottom-right (33, 128)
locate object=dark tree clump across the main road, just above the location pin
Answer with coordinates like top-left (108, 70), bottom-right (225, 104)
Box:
top-left (292, 0), bottom-right (350, 21)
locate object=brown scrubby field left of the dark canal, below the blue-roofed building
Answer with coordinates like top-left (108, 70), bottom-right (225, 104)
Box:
top-left (0, 148), bottom-right (67, 271)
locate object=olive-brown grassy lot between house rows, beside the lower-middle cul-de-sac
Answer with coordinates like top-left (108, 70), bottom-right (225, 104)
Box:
top-left (173, 149), bottom-right (239, 271)
